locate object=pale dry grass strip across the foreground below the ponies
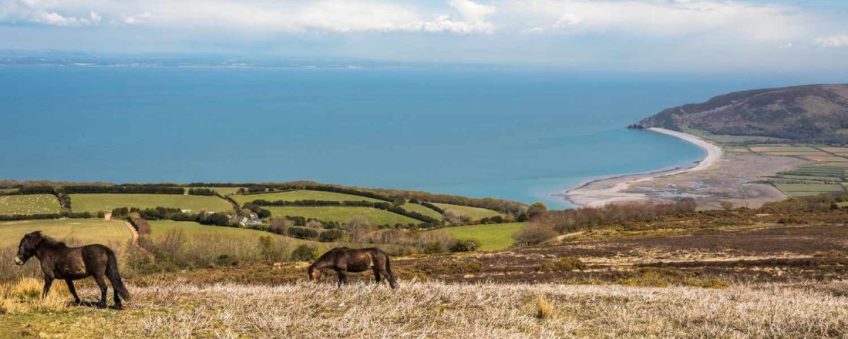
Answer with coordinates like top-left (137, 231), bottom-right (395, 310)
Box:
top-left (0, 282), bottom-right (848, 338)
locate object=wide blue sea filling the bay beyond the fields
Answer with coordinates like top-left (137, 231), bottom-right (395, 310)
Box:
top-left (0, 67), bottom-right (836, 207)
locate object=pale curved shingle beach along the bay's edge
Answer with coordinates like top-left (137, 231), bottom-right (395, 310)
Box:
top-left (562, 127), bottom-right (723, 207)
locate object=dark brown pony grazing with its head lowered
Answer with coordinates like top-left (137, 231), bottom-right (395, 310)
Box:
top-left (307, 247), bottom-right (398, 288)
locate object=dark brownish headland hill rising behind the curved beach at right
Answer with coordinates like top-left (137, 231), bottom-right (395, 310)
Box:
top-left (639, 84), bottom-right (848, 143)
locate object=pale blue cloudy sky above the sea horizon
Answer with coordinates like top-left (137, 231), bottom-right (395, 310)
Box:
top-left (0, 0), bottom-right (848, 72)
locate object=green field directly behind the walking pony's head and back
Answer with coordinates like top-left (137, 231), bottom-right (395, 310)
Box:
top-left (0, 219), bottom-right (132, 248)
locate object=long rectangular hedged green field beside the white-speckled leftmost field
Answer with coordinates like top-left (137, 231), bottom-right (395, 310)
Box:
top-left (71, 194), bottom-right (233, 212)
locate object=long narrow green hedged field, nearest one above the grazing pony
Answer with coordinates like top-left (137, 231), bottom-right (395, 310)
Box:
top-left (264, 206), bottom-right (421, 225)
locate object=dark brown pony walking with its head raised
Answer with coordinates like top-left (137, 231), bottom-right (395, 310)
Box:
top-left (15, 231), bottom-right (130, 308)
